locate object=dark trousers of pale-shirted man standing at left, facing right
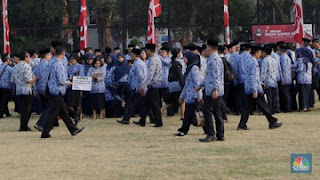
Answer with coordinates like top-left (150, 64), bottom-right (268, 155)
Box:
top-left (19, 95), bottom-right (33, 130)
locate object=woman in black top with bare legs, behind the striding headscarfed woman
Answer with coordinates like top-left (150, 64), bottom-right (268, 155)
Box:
top-left (161, 49), bottom-right (185, 120)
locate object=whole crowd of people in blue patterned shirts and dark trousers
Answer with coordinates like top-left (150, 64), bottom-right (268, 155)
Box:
top-left (0, 39), bottom-right (320, 142)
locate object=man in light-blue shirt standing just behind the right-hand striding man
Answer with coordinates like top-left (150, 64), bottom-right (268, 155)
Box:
top-left (260, 47), bottom-right (280, 114)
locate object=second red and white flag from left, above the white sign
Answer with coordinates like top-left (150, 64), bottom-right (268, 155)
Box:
top-left (79, 0), bottom-right (88, 50)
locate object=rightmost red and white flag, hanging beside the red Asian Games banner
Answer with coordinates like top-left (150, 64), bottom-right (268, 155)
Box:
top-left (293, 0), bottom-right (303, 46)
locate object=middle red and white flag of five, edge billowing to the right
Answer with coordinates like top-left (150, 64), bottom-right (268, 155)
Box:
top-left (147, 0), bottom-right (162, 44)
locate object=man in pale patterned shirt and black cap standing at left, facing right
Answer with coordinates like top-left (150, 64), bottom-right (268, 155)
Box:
top-left (11, 51), bottom-right (37, 131)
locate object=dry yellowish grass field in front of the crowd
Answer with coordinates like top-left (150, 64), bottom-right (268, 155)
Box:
top-left (0, 102), bottom-right (320, 180)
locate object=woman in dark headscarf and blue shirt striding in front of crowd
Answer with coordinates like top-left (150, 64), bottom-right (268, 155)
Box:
top-left (175, 52), bottom-right (203, 136)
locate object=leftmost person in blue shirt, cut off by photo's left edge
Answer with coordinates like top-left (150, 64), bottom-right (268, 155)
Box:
top-left (0, 54), bottom-right (13, 119)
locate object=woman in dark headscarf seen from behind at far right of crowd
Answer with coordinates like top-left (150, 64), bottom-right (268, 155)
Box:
top-left (295, 48), bottom-right (313, 112)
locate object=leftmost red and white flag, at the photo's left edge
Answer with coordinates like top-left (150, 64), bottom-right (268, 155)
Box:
top-left (2, 0), bottom-right (11, 54)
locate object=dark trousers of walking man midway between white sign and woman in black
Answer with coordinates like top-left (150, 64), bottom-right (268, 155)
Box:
top-left (123, 92), bottom-right (142, 121)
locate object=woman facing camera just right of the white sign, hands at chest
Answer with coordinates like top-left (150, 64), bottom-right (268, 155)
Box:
top-left (88, 56), bottom-right (106, 119)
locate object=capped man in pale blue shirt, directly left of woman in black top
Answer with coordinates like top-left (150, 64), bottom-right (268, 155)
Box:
top-left (134, 44), bottom-right (163, 127)
